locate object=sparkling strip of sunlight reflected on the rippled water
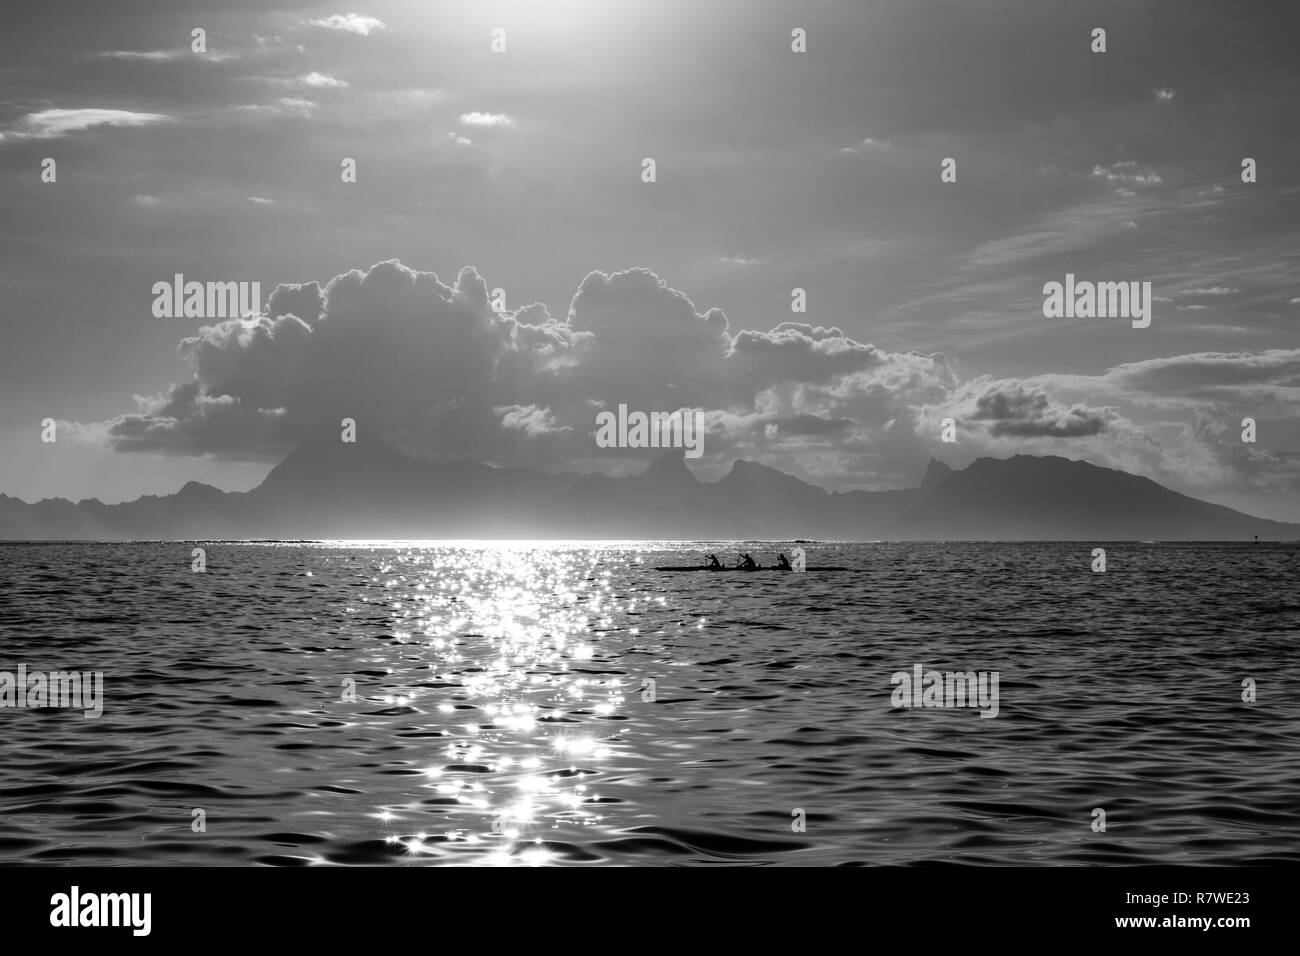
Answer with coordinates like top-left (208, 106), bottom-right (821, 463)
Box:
top-left (348, 545), bottom-right (624, 866)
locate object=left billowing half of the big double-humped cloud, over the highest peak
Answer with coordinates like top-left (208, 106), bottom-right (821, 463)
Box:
top-left (96, 261), bottom-right (590, 460)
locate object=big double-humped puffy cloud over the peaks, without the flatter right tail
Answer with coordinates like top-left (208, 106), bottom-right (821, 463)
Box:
top-left (83, 261), bottom-right (944, 473)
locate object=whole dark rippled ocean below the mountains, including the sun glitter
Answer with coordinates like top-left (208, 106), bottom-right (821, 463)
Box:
top-left (0, 541), bottom-right (1300, 866)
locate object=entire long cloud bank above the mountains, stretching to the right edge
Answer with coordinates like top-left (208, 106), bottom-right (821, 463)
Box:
top-left (79, 260), bottom-right (1300, 502)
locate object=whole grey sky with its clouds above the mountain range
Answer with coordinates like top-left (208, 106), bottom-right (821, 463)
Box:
top-left (0, 0), bottom-right (1300, 520)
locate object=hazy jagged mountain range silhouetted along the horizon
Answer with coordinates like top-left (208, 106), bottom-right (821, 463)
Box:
top-left (0, 432), bottom-right (1300, 541)
